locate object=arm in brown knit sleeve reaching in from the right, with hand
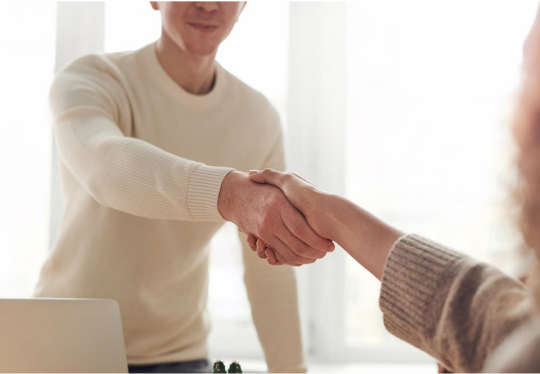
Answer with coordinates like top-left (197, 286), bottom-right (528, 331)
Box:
top-left (251, 170), bottom-right (532, 374)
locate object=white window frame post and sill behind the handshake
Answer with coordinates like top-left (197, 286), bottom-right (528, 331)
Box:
top-left (287, 1), bottom-right (433, 363)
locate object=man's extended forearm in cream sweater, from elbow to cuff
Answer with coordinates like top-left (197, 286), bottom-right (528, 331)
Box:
top-left (56, 109), bottom-right (232, 221)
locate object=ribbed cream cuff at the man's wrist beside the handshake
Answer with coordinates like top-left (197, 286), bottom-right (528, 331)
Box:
top-left (186, 164), bottom-right (234, 221)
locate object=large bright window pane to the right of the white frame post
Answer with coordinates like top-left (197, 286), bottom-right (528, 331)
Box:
top-left (345, 2), bottom-right (537, 356)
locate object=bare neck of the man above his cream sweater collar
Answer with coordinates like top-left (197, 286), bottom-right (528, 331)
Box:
top-left (156, 34), bottom-right (216, 95)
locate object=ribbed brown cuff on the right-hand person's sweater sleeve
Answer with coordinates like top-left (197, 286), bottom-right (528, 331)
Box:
top-left (379, 235), bottom-right (465, 347)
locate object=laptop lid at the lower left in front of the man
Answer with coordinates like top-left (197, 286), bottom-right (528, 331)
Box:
top-left (0, 299), bottom-right (128, 374)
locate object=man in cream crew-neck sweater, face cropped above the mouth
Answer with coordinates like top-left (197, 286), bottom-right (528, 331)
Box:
top-left (36, 1), bottom-right (333, 374)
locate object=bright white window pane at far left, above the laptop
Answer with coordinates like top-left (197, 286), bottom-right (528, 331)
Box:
top-left (0, 1), bottom-right (56, 297)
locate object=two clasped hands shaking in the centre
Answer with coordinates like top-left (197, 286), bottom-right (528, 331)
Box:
top-left (218, 169), bottom-right (335, 266)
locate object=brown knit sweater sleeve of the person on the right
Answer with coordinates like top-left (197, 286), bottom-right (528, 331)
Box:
top-left (380, 235), bottom-right (532, 374)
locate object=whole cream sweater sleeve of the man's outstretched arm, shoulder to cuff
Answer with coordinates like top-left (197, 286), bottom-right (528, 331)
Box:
top-left (50, 57), bottom-right (232, 221)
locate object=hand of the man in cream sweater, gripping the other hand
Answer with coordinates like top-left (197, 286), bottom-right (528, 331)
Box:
top-left (218, 171), bottom-right (334, 265)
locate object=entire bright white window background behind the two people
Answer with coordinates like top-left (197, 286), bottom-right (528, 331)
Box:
top-left (0, 1), bottom-right (538, 372)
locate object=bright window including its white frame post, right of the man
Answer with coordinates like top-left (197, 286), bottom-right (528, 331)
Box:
top-left (288, 2), bottom-right (537, 361)
